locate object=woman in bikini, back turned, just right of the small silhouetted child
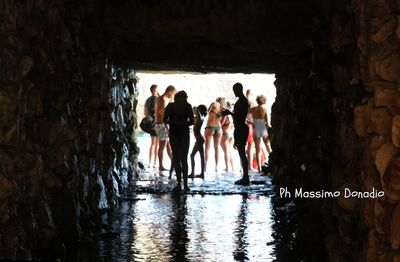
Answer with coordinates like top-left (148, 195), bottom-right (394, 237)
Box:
top-left (204, 102), bottom-right (222, 172)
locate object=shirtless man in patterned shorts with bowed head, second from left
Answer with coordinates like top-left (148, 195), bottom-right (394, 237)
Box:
top-left (154, 86), bottom-right (176, 171)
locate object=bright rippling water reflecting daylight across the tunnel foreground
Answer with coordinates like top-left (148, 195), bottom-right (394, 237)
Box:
top-left (88, 194), bottom-right (273, 261)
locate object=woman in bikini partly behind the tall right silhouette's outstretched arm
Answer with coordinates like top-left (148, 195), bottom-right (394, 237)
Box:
top-left (220, 100), bottom-right (234, 172)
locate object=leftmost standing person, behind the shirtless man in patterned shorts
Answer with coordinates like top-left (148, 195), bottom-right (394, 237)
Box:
top-left (144, 85), bottom-right (158, 168)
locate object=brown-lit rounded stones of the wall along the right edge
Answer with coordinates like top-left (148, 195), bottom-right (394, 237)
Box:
top-left (353, 0), bottom-right (400, 261)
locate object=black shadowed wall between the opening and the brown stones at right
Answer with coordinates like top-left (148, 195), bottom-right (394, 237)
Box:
top-left (270, 0), bottom-right (369, 261)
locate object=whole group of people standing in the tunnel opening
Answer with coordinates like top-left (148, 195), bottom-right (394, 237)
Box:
top-left (144, 83), bottom-right (271, 191)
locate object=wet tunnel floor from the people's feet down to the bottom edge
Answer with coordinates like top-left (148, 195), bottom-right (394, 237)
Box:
top-left (78, 169), bottom-right (274, 261)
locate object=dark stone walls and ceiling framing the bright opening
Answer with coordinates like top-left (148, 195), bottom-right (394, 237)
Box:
top-left (0, 0), bottom-right (400, 261)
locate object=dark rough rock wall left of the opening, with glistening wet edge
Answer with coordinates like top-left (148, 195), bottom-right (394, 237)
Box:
top-left (0, 0), bottom-right (137, 259)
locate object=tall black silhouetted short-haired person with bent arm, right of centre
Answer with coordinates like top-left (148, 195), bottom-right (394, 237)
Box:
top-left (222, 83), bottom-right (250, 185)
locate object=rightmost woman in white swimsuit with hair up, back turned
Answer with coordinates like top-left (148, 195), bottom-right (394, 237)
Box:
top-left (250, 95), bottom-right (271, 172)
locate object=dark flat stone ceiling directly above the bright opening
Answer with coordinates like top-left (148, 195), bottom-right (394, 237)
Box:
top-left (103, 0), bottom-right (311, 72)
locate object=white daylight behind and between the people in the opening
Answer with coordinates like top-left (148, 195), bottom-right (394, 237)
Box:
top-left (136, 71), bottom-right (276, 175)
